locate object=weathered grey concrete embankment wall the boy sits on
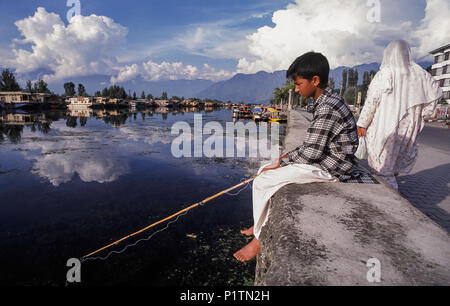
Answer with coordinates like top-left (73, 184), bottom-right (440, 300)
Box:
top-left (255, 111), bottom-right (450, 286)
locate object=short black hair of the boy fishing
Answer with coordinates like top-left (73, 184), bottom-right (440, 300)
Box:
top-left (286, 52), bottom-right (330, 88)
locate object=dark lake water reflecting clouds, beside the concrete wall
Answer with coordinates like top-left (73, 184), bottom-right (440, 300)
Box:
top-left (0, 109), bottom-right (284, 286)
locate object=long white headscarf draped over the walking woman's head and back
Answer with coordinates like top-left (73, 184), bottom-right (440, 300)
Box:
top-left (367, 40), bottom-right (443, 156)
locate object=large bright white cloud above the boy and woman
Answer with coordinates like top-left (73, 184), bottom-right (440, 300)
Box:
top-left (238, 0), bottom-right (450, 73)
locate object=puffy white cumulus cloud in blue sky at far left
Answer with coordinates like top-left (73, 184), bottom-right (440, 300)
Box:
top-left (13, 7), bottom-right (128, 82)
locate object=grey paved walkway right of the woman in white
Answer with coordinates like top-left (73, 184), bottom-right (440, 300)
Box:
top-left (301, 112), bottom-right (450, 233)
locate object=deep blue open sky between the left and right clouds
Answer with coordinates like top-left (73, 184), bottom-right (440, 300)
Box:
top-left (0, 0), bottom-right (290, 69)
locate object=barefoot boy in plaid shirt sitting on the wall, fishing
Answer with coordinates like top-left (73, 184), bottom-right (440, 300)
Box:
top-left (234, 52), bottom-right (377, 261)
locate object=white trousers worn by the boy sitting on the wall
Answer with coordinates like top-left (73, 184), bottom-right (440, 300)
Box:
top-left (253, 164), bottom-right (339, 239)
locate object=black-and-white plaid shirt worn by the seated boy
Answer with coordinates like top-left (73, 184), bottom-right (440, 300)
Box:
top-left (280, 87), bottom-right (377, 184)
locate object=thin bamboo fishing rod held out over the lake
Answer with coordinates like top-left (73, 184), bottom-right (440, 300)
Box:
top-left (81, 174), bottom-right (259, 260)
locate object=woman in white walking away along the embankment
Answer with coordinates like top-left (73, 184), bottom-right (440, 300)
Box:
top-left (357, 40), bottom-right (443, 189)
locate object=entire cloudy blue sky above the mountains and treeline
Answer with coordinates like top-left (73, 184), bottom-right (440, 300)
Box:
top-left (0, 0), bottom-right (450, 83)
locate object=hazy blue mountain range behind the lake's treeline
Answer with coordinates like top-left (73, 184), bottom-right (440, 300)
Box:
top-left (7, 62), bottom-right (432, 103)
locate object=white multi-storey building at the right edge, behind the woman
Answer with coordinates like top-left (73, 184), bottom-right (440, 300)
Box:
top-left (430, 44), bottom-right (450, 103)
